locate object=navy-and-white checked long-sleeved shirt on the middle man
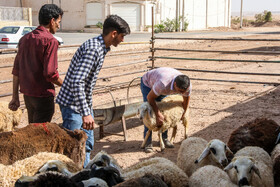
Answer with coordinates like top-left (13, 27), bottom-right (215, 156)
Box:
top-left (56, 35), bottom-right (110, 116)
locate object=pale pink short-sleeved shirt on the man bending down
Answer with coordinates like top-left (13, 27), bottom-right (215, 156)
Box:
top-left (142, 67), bottom-right (192, 97)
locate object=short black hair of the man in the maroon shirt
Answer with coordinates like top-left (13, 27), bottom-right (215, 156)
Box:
top-left (39, 4), bottom-right (63, 25)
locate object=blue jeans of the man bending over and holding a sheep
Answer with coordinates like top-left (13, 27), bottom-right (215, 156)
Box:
top-left (140, 78), bottom-right (168, 145)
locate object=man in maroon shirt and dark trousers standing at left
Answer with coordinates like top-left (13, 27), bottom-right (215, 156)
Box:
top-left (9, 4), bottom-right (63, 123)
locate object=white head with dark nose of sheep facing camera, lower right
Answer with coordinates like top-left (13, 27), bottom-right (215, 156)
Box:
top-left (224, 156), bottom-right (261, 186)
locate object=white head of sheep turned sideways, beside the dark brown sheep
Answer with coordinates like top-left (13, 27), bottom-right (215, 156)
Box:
top-left (195, 139), bottom-right (232, 167)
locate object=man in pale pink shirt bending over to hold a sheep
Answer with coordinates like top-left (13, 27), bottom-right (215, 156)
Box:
top-left (141, 67), bottom-right (192, 153)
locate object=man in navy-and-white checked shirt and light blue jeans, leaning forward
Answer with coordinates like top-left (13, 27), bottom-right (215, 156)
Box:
top-left (56, 15), bottom-right (130, 167)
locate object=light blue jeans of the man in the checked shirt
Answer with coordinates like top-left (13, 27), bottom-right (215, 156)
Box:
top-left (59, 105), bottom-right (94, 167)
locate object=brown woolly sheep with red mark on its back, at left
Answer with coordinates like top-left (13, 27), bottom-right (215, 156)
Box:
top-left (0, 123), bottom-right (87, 168)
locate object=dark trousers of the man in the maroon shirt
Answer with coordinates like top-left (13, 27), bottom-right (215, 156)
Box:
top-left (23, 95), bottom-right (54, 123)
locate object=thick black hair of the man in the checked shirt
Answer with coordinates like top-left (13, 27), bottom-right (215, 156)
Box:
top-left (102, 15), bottom-right (130, 36)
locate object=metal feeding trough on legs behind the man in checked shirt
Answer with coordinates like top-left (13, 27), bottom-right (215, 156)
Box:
top-left (93, 98), bottom-right (143, 141)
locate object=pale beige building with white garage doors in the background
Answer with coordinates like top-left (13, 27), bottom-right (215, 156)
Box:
top-left (0, 0), bottom-right (231, 31)
